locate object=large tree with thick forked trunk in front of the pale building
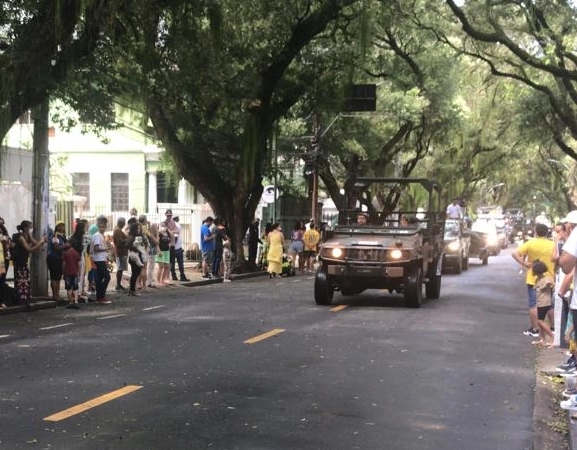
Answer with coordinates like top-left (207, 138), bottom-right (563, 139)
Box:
top-left (110, 0), bottom-right (359, 268)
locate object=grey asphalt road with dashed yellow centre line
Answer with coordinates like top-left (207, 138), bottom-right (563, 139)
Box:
top-left (0, 250), bottom-right (535, 450)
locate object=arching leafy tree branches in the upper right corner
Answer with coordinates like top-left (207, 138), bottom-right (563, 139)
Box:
top-left (441, 0), bottom-right (577, 159)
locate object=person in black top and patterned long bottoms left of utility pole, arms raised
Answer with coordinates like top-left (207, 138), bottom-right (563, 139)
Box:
top-left (12, 220), bottom-right (48, 307)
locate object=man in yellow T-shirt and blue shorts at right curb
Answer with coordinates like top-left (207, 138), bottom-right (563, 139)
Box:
top-left (512, 223), bottom-right (555, 337)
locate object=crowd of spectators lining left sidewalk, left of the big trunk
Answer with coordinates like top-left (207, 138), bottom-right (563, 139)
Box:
top-left (0, 209), bottom-right (231, 309)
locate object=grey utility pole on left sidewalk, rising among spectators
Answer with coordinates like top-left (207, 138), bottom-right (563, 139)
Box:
top-left (30, 100), bottom-right (50, 297)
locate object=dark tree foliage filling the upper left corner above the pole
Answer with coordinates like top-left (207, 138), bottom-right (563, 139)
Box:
top-left (0, 0), bottom-right (122, 141)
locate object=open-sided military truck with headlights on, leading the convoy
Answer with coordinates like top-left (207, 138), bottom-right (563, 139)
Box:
top-left (314, 178), bottom-right (446, 308)
